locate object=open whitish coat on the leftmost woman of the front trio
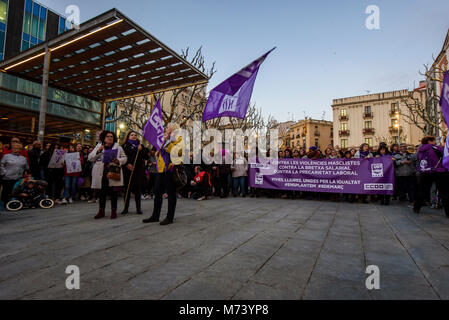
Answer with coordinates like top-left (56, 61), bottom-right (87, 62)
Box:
top-left (89, 143), bottom-right (128, 189)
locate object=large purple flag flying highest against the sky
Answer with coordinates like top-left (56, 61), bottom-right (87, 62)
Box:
top-left (203, 48), bottom-right (276, 122)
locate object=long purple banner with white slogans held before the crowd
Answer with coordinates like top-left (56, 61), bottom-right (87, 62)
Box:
top-left (249, 157), bottom-right (394, 195)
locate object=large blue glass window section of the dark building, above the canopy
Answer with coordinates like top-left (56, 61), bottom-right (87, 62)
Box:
top-left (22, 0), bottom-right (48, 51)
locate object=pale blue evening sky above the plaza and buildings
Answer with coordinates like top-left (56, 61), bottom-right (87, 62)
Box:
top-left (39, 0), bottom-right (449, 121)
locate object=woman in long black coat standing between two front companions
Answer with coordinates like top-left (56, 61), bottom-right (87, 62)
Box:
top-left (122, 131), bottom-right (149, 214)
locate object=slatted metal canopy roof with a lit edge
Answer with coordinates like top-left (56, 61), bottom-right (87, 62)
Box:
top-left (0, 9), bottom-right (208, 101)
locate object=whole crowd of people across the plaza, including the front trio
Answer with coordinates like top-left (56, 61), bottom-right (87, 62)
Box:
top-left (0, 131), bottom-right (449, 224)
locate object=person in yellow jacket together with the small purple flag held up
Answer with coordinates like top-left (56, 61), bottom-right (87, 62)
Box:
top-left (143, 100), bottom-right (184, 225)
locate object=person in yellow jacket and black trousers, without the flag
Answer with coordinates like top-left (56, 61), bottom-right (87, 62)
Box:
top-left (143, 124), bottom-right (184, 226)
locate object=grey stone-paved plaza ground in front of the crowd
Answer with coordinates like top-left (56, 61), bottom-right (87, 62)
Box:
top-left (0, 198), bottom-right (449, 299)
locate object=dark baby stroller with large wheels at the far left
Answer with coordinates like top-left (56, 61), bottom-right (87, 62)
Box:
top-left (6, 180), bottom-right (55, 211)
